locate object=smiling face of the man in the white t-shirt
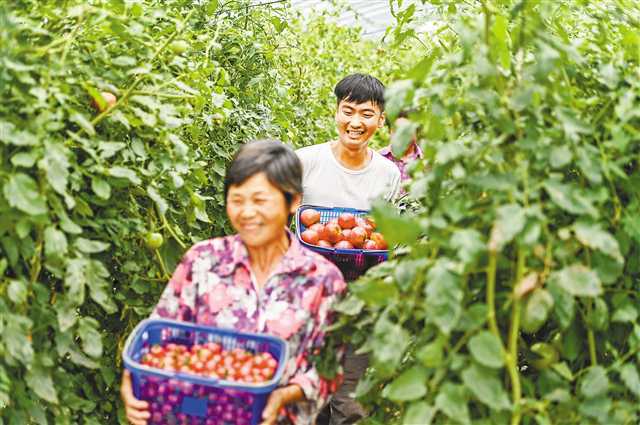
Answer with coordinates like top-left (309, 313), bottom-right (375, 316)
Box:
top-left (336, 100), bottom-right (384, 150)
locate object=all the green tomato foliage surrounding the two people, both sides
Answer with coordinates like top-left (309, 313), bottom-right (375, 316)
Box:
top-left (0, 0), bottom-right (640, 425)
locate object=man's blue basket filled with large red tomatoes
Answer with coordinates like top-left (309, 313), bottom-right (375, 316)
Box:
top-left (296, 205), bottom-right (388, 281)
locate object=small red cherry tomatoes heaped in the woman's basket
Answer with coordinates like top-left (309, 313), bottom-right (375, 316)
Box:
top-left (141, 342), bottom-right (278, 383)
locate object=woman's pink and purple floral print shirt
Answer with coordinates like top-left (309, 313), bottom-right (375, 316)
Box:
top-left (153, 231), bottom-right (346, 425)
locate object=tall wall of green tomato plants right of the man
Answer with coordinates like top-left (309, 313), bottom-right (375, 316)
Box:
top-left (335, 0), bottom-right (640, 424)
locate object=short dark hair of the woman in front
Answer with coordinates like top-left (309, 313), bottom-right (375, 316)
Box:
top-left (224, 139), bottom-right (302, 205)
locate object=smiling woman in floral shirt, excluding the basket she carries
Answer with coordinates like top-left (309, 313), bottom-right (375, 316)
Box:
top-left (121, 140), bottom-right (345, 425)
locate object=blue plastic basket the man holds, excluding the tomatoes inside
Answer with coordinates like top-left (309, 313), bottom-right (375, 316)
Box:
top-left (296, 205), bottom-right (389, 282)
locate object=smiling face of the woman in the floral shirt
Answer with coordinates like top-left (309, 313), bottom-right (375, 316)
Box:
top-left (227, 173), bottom-right (300, 248)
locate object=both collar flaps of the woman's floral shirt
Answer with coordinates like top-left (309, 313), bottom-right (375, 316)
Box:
top-left (217, 229), bottom-right (314, 276)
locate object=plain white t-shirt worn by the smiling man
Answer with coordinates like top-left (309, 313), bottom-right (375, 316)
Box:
top-left (296, 142), bottom-right (400, 210)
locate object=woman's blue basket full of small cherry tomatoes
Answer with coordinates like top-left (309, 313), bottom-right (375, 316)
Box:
top-left (123, 319), bottom-right (288, 425)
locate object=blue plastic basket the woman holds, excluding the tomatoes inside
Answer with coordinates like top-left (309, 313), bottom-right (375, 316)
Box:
top-left (122, 319), bottom-right (289, 425)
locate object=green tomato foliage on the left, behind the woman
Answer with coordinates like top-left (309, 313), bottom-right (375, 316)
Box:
top-left (0, 0), bottom-right (400, 425)
